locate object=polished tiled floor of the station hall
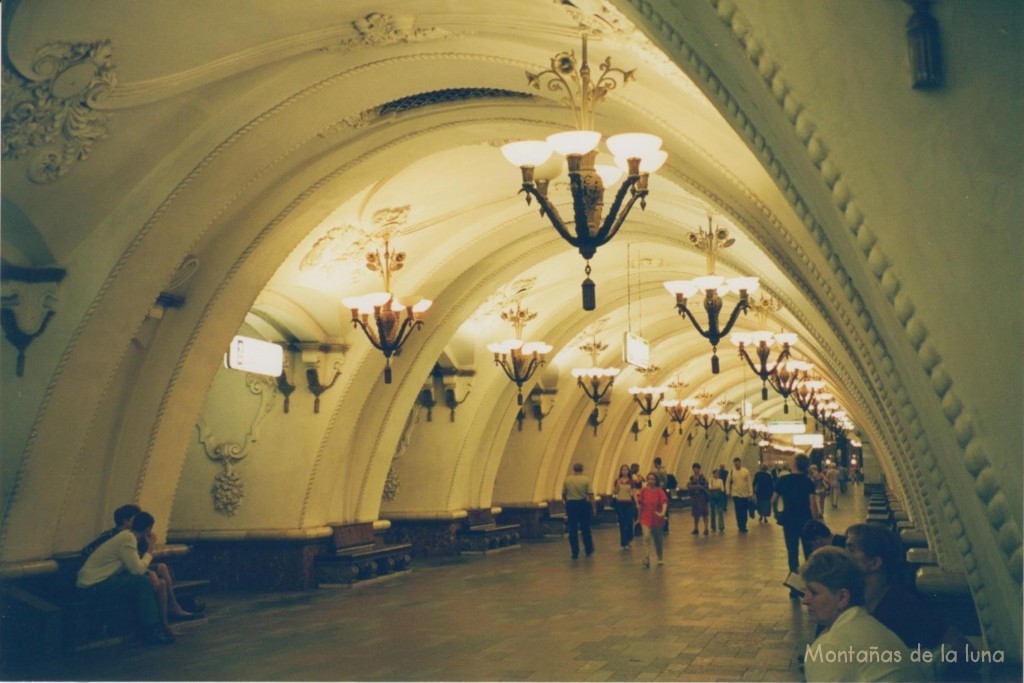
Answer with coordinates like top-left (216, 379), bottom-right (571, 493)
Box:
top-left (19, 487), bottom-right (865, 681)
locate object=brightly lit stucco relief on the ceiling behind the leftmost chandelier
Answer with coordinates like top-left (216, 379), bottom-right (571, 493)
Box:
top-left (299, 206), bottom-right (412, 281)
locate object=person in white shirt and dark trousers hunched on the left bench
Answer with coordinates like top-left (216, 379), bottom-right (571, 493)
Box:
top-left (75, 512), bottom-right (174, 644)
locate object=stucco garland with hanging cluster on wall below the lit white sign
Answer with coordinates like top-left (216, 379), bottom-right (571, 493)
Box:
top-left (196, 374), bottom-right (278, 517)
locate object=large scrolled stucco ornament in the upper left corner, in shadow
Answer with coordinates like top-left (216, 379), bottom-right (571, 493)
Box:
top-left (2, 40), bottom-right (117, 183)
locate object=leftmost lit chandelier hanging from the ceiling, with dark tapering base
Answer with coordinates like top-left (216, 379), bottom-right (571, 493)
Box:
top-left (342, 240), bottom-right (432, 384)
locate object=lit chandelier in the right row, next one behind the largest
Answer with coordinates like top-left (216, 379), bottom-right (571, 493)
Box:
top-left (665, 215), bottom-right (759, 375)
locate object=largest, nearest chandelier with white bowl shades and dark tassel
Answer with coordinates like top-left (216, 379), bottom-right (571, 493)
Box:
top-left (502, 34), bottom-right (668, 310)
